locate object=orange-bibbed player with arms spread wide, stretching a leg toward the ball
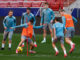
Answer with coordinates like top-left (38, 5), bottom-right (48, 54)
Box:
top-left (13, 19), bottom-right (43, 53)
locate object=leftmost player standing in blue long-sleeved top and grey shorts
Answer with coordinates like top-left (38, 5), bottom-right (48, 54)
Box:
top-left (1, 10), bottom-right (16, 50)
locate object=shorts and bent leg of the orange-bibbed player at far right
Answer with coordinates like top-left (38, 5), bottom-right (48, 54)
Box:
top-left (65, 29), bottom-right (75, 53)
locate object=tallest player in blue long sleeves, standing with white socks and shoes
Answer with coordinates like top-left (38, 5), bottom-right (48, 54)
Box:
top-left (40, 3), bottom-right (55, 43)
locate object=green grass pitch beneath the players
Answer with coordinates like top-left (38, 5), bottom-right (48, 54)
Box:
top-left (0, 34), bottom-right (80, 60)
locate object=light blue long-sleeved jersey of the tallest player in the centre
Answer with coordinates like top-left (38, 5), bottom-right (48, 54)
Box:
top-left (41, 8), bottom-right (55, 24)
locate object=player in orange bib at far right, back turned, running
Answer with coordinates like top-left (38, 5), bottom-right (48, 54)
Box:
top-left (60, 10), bottom-right (77, 53)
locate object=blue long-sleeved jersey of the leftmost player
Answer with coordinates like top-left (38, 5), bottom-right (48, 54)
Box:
top-left (3, 16), bottom-right (16, 32)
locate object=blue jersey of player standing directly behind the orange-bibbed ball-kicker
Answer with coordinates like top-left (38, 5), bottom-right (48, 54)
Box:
top-left (21, 13), bottom-right (36, 25)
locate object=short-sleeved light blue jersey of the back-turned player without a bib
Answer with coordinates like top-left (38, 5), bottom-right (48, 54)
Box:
top-left (53, 22), bottom-right (65, 37)
